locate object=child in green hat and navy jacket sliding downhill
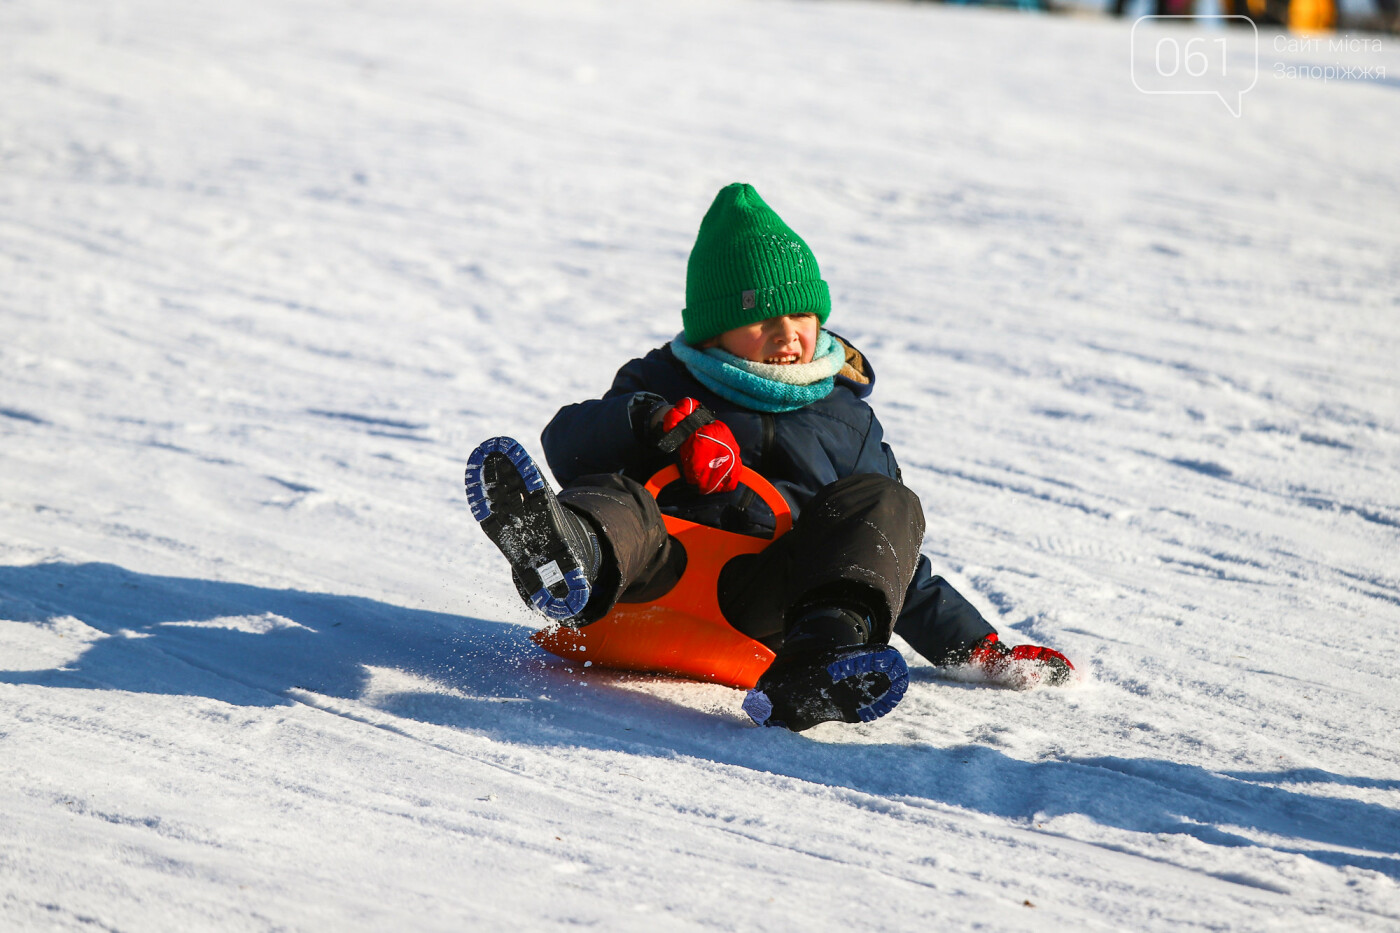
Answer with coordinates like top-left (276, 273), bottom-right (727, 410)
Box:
top-left (466, 184), bottom-right (1072, 731)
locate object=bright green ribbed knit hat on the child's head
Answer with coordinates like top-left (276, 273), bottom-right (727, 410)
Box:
top-left (680, 184), bottom-right (832, 346)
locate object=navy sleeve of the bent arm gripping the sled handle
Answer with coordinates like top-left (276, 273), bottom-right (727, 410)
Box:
top-left (540, 360), bottom-right (666, 486)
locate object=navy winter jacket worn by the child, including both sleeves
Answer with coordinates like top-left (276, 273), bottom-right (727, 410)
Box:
top-left (540, 335), bottom-right (994, 663)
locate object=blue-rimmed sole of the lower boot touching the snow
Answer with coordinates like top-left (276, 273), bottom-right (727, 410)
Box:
top-left (743, 644), bottom-right (909, 731)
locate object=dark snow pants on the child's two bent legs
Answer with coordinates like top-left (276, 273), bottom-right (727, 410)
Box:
top-left (559, 474), bottom-right (929, 650)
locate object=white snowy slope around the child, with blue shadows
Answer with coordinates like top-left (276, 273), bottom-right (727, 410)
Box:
top-left (0, 0), bottom-right (1400, 933)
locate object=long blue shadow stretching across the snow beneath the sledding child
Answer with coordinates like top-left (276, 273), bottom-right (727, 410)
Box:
top-left (0, 563), bottom-right (1400, 891)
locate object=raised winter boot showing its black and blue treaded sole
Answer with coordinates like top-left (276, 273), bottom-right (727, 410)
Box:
top-left (466, 437), bottom-right (602, 622)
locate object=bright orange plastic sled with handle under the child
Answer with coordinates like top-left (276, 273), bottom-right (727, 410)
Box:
top-left (531, 467), bottom-right (792, 689)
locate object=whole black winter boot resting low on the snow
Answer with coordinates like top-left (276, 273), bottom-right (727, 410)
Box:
top-left (743, 605), bottom-right (909, 733)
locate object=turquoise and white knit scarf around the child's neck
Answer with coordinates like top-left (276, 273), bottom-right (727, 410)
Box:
top-left (671, 331), bottom-right (846, 412)
